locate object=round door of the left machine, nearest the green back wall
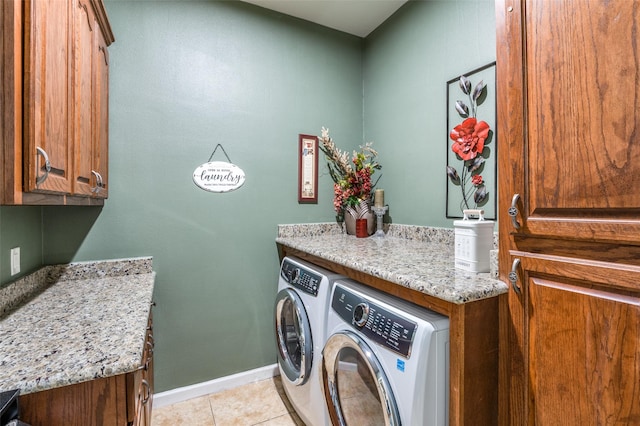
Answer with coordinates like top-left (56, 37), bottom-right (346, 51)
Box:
top-left (275, 288), bottom-right (313, 385)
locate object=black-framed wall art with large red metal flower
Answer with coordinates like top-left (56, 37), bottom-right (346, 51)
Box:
top-left (446, 61), bottom-right (498, 220)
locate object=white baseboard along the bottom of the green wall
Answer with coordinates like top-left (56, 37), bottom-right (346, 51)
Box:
top-left (153, 364), bottom-right (280, 407)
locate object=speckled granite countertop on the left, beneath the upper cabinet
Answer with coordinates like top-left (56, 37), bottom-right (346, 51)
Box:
top-left (0, 258), bottom-right (155, 394)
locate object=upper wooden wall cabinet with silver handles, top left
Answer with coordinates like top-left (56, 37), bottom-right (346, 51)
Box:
top-left (2, 0), bottom-right (114, 205)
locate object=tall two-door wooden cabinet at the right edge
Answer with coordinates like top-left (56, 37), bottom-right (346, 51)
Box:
top-left (496, 0), bottom-right (640, 425)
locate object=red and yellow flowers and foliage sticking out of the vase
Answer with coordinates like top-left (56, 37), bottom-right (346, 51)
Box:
top-left (319, 127), bottom-right (382, 216)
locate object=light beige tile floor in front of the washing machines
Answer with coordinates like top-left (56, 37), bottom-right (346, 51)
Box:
top-left (151, 376), bottom-right (304, 426)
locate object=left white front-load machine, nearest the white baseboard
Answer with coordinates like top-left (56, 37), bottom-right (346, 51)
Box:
top-left (275, 257), bottom-right (341, 426)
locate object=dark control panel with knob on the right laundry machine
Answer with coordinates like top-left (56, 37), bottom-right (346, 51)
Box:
top-left (331, 285), bottom-right (418, 358)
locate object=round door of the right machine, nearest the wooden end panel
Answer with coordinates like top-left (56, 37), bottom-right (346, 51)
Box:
top-left (321, 330), bottom-right (401, 426)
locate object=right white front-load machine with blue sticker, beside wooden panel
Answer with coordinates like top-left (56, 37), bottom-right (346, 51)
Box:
top-left (320, 279), bottom-right (449, 426)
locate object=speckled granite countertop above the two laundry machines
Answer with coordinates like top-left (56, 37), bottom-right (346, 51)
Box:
top-left (276, 224), bottom-right (508, 304)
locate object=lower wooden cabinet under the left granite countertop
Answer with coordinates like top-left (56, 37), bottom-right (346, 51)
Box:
top-left (20, 313), bottom-right (153, 426)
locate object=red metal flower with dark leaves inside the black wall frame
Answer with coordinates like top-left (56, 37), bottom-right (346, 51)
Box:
top-left (447, 76), bottom-right (493, 210)
